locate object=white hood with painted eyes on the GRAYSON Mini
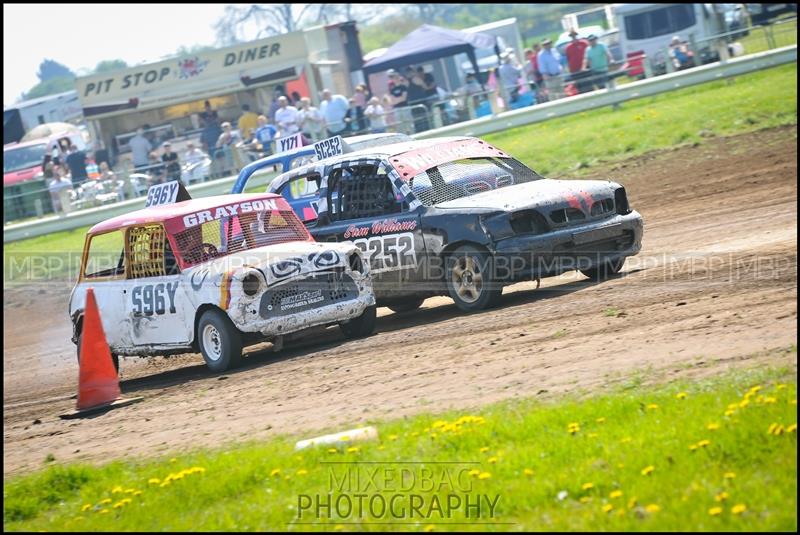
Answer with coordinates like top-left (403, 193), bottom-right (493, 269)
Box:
top-left (184, 241), bottom-right (358, 285)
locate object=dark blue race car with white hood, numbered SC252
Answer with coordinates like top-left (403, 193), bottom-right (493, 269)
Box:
top-left (269, 137), bottom-right (643, 311)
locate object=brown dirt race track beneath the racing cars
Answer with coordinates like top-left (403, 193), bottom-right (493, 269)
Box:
top-left (3, 127), bottom-right (797, 473)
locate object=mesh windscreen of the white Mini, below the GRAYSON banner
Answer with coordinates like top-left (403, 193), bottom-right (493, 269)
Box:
top-left (175, 210), bottom-right (309, 266)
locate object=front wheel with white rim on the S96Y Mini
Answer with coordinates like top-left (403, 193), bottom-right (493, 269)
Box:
top-left (197, 309), bottom-right (242, 372)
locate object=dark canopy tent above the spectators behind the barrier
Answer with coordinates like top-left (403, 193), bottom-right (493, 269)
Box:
top-left (363, 24), bottom-right (500, 86)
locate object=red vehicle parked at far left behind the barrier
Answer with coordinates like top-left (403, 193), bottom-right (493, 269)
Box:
top-left (3, 127), bottom-right (87, 186)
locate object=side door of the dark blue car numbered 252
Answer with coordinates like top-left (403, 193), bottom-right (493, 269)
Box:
top-left (309, 160), bottom-right (425, 299)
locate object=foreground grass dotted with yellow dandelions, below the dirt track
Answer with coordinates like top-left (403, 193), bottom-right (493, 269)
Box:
top-left (3, 364), bottom-right (797, 531)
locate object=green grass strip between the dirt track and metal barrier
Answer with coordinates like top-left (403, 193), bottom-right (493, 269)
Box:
top-left (3, 65), bottom-right (797, 282)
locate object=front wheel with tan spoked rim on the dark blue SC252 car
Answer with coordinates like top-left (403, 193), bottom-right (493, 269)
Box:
top-left (446, 245), bottom-right (503, 312)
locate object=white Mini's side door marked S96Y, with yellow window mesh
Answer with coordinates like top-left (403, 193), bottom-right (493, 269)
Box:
top-left (122, 224), bottom-right (193, 346)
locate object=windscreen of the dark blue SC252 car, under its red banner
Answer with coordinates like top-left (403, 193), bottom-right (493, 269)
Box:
top-left (409, 158), bottom-right (542, 206)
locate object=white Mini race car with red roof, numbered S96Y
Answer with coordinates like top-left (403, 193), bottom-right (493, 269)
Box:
top-left (69, 186), bottom-right (375, 371)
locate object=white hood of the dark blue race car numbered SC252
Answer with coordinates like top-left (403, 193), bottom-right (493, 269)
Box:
top-left (436, 178), bottom-right (620, 212)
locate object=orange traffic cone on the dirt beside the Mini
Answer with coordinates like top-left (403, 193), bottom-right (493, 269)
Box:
top-left (61, 288), bottom-right (142, 418)
